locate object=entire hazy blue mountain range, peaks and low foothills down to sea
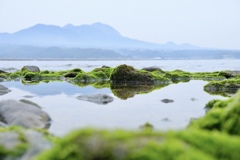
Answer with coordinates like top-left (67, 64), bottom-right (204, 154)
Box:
top-left (0, 23), bottom-right (240, 60)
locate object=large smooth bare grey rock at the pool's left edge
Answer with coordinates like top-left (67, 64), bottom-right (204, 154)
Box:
top-left (0, 100), bottom-right (51, 128)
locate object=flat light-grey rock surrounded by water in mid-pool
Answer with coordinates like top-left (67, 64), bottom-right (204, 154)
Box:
top-left (77, 94), bottom-right (113, 104)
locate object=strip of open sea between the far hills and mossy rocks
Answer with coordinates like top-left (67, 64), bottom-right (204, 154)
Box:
top-left (0, 60), bottom-right (240, 72)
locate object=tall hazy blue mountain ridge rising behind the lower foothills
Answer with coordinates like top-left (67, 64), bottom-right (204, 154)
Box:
top-left (0, 23), bottom-right (200, 50)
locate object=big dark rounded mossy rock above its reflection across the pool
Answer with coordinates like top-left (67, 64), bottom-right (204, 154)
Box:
top-left (110, 64), bottom-right (154, 84)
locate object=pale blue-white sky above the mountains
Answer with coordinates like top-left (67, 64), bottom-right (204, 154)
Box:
top-left (0, 0), bottom-right (240, 50)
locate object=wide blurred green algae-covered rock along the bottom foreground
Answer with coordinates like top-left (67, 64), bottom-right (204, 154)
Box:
top-left (36, 129), bottom-right (240, 160)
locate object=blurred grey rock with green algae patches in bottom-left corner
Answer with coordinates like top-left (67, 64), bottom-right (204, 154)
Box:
top-left (0, 127), bottom-right (51, 160)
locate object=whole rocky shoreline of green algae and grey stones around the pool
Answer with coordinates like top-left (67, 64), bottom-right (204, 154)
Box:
top-left (0, 65), bottom-right (240, 160)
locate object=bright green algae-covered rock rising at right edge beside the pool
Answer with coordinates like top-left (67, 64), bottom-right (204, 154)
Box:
top-left (189, 91), bottom-right (240, 135)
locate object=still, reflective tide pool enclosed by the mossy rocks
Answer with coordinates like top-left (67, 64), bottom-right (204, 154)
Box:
top-left (0, 81), bottom-right (223, 135)
